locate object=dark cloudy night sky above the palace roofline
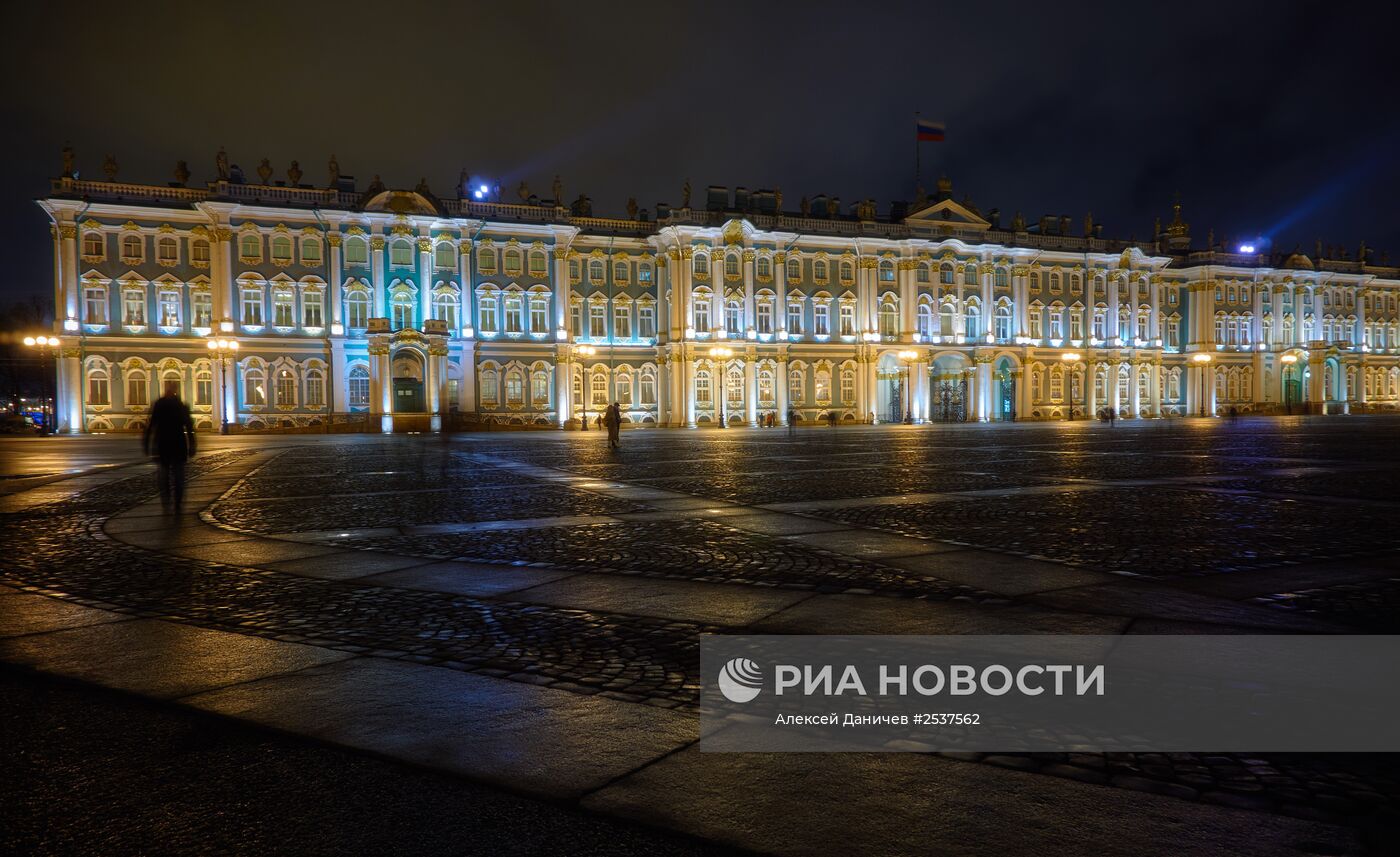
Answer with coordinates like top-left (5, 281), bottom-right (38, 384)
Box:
top-left (0, 0), bottom-right (1400, 306)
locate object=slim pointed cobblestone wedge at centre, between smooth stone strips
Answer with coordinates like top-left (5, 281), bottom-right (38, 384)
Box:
top-left (346, 521), bottom-right (1004, 602)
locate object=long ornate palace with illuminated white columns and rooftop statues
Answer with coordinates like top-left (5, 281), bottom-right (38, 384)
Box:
top-left (39, 153), bottom-right (1400, 433)
